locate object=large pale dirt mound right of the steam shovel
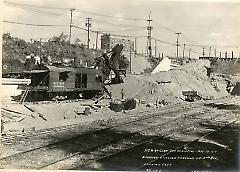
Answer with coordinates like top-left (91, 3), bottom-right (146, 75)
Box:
top-left (108, 60), bottom-right (228, 103)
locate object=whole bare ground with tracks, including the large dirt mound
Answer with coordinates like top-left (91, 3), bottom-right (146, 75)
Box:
top-left (0, 61), bottom-right (240, 170)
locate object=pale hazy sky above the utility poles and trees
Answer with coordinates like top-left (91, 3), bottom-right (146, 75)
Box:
top-left (2, 0), bottom-right (240, 56)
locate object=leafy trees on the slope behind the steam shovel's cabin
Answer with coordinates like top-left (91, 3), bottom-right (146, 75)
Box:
top-left (3, 33), bottom-right (99, 65)
